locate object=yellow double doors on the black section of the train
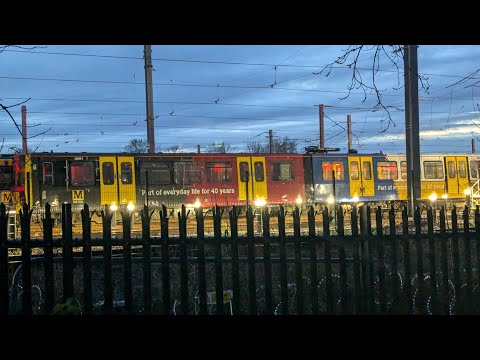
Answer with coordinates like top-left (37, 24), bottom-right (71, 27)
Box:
top-left (100, 156), bottom-right (136, 206)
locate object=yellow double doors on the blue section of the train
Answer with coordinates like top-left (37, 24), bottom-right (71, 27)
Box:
top-left (348, 156), bottom-right (375, 196)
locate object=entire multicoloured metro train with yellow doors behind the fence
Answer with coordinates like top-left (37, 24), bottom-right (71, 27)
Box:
top-left (0, 153), bottom-right (480, 218)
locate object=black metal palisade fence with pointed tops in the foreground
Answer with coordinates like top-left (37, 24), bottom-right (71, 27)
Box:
top-left (0, 204), bottom-right (480, 315)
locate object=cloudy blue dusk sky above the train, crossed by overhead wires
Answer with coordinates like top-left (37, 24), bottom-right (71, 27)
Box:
top-left (0, 45), bottom-right (480, 153)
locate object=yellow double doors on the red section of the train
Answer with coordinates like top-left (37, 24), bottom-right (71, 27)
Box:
top-left (237, 156), bottom-right (267, 201)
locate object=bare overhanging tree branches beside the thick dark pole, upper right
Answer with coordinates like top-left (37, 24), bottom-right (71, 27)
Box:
top-left (313, 45), bottom-right (429, 132)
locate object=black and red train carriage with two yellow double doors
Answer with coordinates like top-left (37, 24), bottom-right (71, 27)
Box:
top-left (14, 153), bottom-right (305, 220)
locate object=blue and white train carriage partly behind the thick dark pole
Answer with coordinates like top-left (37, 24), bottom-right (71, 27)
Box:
top-left (305, 153), bottom-right (480, 207)
